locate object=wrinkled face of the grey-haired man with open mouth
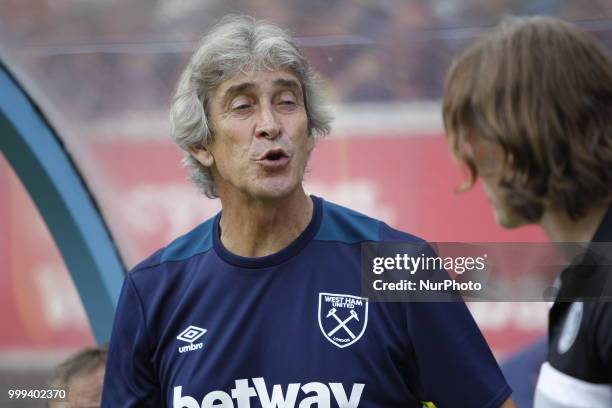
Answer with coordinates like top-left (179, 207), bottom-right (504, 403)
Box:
top-left (193, 70), bottom-right (314, 200)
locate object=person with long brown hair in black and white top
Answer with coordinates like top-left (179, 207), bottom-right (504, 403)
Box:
top-left (444, 17), bottom-right (612, 408)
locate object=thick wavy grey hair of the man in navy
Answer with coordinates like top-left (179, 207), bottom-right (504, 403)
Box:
top-left (170, 15), bottom-right (332, 198)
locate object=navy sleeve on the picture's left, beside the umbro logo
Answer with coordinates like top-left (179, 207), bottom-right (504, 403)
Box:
top-left (102, 273), bottom-right (163, 408)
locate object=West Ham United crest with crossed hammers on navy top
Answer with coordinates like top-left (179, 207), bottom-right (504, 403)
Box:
top-left (319, 293), bottom-right (368, 348)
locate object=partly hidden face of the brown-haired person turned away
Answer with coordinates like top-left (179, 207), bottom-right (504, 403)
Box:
top-left (468, 135), bottom-right (529, 228)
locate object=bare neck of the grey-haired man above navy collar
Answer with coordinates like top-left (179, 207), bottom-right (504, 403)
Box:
top-left (219, 186), bottom-right (313, 257)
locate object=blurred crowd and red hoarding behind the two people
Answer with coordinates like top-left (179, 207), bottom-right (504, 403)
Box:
top-left (0, 0), bottom-right (612, 406)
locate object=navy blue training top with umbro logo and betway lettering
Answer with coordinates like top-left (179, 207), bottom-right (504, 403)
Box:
top-left (102, 196), bottom-right (511, 408)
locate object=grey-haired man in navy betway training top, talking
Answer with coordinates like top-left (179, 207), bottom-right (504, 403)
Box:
top-left (102, 17), bottom-right (513, 408)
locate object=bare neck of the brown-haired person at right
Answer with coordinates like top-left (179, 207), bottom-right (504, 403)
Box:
top-left (540, 204), bottom-right (609, 243)
